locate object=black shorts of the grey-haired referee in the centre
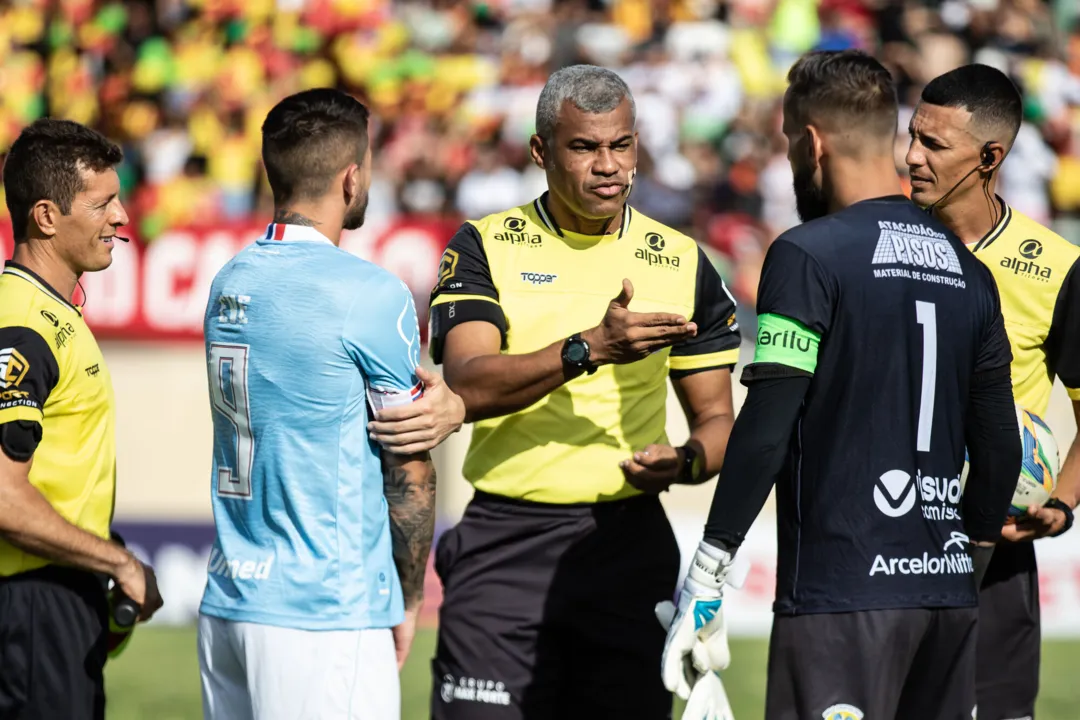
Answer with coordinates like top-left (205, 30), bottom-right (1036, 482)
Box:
top-left (431, 492), bottom-right (679, 720)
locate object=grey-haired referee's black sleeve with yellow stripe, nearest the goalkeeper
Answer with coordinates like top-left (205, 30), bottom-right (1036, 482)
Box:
top-left (669, 247), bottom-right (741, 378)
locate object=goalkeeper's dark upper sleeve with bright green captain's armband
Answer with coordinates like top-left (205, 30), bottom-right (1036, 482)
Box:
top-left (742, 236), bottom-right (836, 384)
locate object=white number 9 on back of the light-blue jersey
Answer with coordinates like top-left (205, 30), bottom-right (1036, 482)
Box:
top-left (210, 342), bottom-right (255, 500)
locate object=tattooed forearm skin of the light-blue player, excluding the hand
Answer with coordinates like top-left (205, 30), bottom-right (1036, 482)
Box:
top-left (383, 460), bottom-right (435, 607)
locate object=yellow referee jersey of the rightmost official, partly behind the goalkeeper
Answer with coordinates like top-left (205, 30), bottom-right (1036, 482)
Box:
top-left (969, 199), bottom-right (1080, 416)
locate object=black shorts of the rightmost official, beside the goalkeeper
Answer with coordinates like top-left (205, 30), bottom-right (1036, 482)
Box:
top-left (975, 543), bottom-right (1041, 720)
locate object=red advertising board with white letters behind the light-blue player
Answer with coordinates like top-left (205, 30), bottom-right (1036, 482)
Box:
top-left (0, 217), bottom-right (458, 340)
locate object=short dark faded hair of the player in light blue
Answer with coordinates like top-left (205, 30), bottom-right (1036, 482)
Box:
top-left (262, 87), bottom-right (368, 205)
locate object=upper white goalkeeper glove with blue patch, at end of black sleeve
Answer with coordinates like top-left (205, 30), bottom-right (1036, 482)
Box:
top-left (657, 541), bottom-right (741, 699)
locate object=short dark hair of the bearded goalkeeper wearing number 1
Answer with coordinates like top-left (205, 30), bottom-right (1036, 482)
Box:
top-left (785, 50), bottom-right (900, 143)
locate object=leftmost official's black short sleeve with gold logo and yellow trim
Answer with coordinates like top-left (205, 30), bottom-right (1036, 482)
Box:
top-left (0, 327), bottom-right (60, 424)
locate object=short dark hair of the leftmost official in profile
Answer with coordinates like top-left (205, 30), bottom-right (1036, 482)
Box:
top-left (3, 118), bottom-right (124, 242)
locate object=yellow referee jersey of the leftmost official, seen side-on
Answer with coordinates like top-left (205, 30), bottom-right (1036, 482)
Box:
top-left (0, 262), bottom-right (116, 575)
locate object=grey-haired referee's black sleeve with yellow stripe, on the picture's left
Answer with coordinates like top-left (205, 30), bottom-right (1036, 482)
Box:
top-left (429, 222), bottom-right (507, 364)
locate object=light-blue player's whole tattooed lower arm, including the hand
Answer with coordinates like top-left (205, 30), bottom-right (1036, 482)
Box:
top-left (382, 452), bottom-right (435, 669)
